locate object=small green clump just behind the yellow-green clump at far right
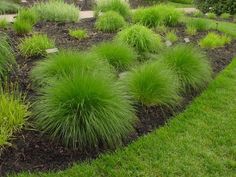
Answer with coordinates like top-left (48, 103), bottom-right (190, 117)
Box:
top-left (187, 18), bottom-right (209, 31)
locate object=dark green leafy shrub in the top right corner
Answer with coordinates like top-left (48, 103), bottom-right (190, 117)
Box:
top-left (195, 0), bottom-right (236, 15)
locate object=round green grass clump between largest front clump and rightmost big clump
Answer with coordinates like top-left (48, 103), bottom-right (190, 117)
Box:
top-left (124, 62), bottom-right (180, 106)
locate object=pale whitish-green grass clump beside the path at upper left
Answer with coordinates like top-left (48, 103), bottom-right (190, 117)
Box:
top-left (32, 1), bottom-right (79, 22)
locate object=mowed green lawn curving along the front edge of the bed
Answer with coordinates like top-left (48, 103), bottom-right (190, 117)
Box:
top-left (14, 58), bottom-right (236, 177)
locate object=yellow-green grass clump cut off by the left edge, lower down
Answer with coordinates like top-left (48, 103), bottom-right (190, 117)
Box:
top-left (0, 88), bottom-right (28, 148)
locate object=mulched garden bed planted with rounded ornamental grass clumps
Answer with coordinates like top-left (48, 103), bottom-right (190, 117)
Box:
top-left (0, 1), bottom-right (236, 175)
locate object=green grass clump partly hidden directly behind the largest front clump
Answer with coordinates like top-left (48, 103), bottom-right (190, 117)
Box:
top-left (31, 51), bottom-right (112, 86)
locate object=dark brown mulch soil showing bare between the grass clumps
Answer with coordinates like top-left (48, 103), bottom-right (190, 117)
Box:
top-left (0, 19), bottom-right (236, 176)
